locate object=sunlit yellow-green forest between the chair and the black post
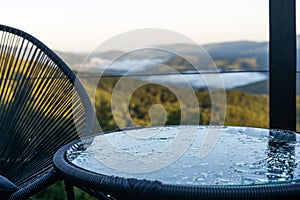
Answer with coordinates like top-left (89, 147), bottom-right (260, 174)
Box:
top-left (95, 78), bottom-right (269, 131)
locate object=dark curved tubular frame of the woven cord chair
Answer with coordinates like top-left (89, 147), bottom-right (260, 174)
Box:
top-left (0, 24), bottom-right (95, 200)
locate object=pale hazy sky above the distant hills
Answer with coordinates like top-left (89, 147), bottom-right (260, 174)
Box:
top-left (0, 0), bottom-right (300, 52)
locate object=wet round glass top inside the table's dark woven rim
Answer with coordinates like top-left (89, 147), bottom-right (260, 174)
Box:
top-left (66, 126), bottom-right (300, 185)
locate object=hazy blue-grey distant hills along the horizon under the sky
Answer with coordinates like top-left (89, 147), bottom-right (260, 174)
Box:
top-left (57, 36), bottom-right (300, 73)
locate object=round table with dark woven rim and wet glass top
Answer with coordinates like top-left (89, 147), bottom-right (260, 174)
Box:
top-left (54, 126), bottom-right (300, 199)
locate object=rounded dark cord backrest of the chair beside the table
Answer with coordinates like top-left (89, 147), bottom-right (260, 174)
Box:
top-left (0, 25), bottom-right (94, 187)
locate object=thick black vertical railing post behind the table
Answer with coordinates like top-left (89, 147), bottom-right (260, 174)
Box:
top-left (269, 0), bottom-right (296, 130)
